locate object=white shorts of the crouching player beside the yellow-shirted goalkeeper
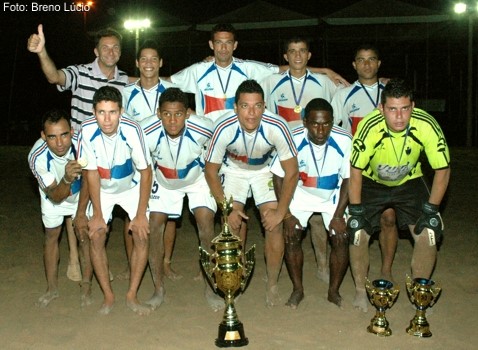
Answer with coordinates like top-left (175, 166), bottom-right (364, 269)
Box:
top-left (290, 187), bottom-right (337, 230)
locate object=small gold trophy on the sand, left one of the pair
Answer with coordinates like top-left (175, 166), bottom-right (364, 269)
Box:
top-left (365, 278), bottom-right (400, 337)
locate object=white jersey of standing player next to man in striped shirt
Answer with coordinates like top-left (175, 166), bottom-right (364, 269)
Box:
top-left (122, 80), bottom-right (175, 123)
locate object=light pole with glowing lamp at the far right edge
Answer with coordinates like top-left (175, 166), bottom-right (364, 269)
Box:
top-left (454, 1), bottom-right (478, 147)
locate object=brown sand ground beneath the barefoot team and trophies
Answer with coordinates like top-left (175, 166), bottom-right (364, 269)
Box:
top-left (0, 146), bottom-right (478, 350)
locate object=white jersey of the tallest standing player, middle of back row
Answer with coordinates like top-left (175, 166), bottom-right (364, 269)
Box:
top-left (171, 57), bottom-right (279, 122)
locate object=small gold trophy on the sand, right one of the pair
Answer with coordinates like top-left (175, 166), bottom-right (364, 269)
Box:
top-left (406, 276), bottom-right (441, 338)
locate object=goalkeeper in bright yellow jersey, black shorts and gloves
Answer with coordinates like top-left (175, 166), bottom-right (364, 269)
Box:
top-left (347, 79), bottom-right (450, 312)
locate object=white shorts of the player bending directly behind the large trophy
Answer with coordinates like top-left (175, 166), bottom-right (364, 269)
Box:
top-left (223, 169), bottom-right (277, 206)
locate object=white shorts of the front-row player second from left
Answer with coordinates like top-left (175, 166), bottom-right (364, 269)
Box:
top-left (87, 184), bottom-right (149, 223)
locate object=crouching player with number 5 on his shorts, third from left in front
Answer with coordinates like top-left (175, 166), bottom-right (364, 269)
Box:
top-left (141, 88), bottom-right (220, 310)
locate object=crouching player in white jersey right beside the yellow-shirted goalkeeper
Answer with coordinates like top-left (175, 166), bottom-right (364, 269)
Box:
top-left (271, 98), bottom-right (352, 309)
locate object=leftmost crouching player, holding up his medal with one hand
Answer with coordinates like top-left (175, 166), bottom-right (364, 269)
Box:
top-left (28, 110), bottom-right (92, 307)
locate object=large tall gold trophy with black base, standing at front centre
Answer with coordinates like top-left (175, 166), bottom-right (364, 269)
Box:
top-left (199, 197), bottom-right (256, 348)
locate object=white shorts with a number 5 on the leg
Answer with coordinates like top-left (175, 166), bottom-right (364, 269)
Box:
top-left (149, 176), bottom-right (217, 219)
